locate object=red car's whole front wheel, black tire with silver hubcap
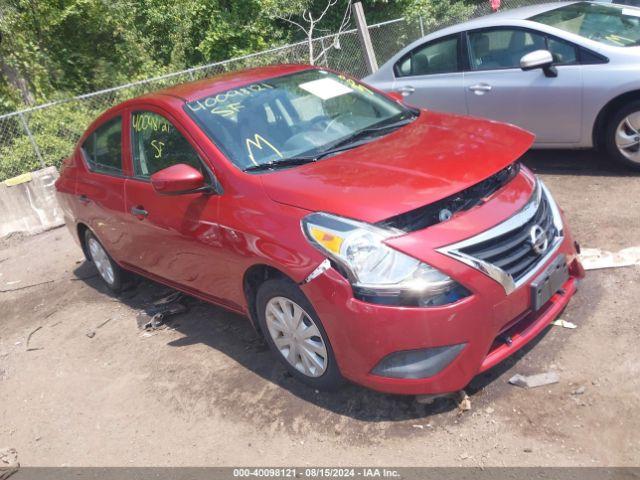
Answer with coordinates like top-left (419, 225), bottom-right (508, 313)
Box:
top-left (256, 279), bottom-right (344, 391)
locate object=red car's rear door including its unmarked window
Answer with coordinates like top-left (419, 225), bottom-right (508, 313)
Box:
top-left (74, 113), bottom-right (126, 261)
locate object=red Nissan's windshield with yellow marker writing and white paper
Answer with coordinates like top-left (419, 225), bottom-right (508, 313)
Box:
top-left (185, 70), bottom-right (414, 170)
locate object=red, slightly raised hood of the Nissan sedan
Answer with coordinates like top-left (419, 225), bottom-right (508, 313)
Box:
top-left (260, 111), bottom-right (534, 223)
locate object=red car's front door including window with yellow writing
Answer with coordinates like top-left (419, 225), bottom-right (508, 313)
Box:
top-left (125, 106), bottom-right (236, 303)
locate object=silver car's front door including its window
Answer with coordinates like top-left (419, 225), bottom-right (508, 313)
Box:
top-left (464, 27), bottom-right (583, 146)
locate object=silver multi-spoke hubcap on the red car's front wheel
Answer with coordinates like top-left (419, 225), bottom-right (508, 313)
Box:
top-left (265, 297), bottom-right (329, 378)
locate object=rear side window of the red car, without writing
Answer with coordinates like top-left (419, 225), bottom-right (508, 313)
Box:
top-left (82, 117), bottom-right (122, 175)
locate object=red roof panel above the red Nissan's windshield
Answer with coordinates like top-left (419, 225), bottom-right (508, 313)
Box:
top-left (142, 65), bottom-right (313, 102)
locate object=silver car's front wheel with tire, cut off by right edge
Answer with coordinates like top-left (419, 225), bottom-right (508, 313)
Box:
top-left (605, 100), bottom-right (640, 171)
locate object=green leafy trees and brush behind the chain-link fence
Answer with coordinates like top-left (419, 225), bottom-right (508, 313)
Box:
top-left (0, 0), bottom-right (488, 180)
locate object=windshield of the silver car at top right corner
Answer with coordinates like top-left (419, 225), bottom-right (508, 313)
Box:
top-left (529, 2), bottom-right (640, 47)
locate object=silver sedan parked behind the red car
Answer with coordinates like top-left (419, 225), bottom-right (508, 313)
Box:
top-left (364, 2), bottom-right (640, 169)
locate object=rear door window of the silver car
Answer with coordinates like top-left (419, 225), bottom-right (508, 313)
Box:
top-left (395, 35), bottom-right (460, 77)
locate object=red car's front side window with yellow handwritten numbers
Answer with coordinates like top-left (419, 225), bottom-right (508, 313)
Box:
top-left (131, 112), bottom-right (205, 179)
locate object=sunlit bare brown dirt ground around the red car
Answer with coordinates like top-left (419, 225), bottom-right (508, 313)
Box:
top-left (0, 152), bottom-right (640, 466)
